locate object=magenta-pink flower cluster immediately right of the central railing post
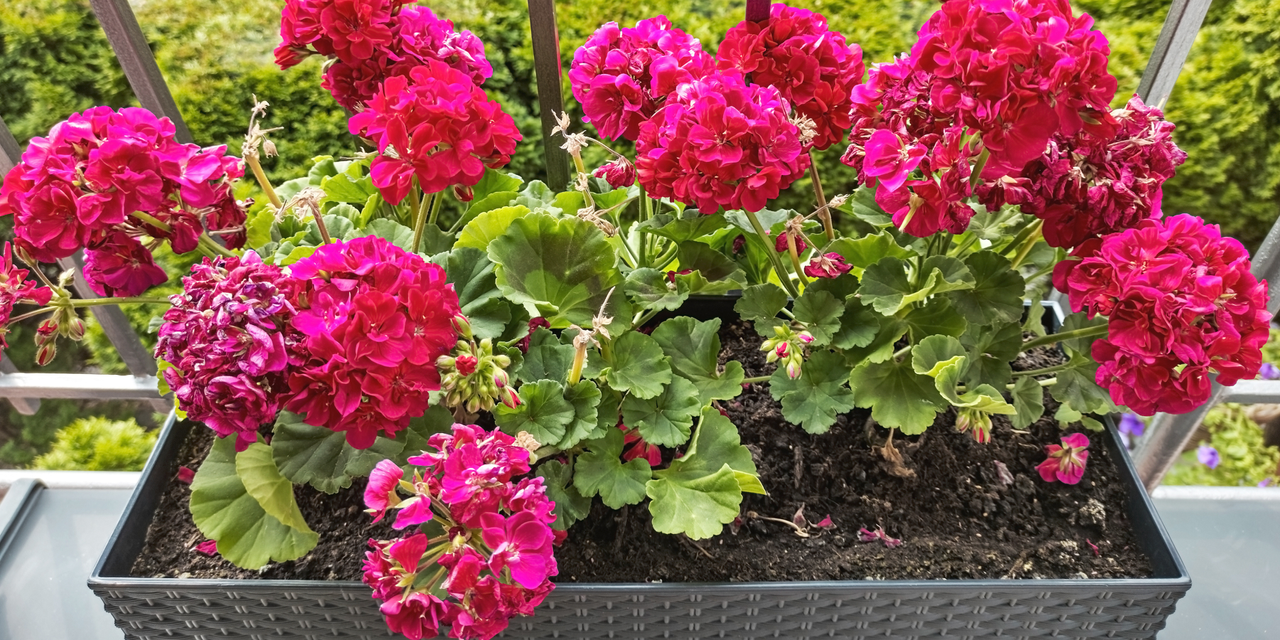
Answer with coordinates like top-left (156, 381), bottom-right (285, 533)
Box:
top-left (568, 15), bottom-right (716, 141)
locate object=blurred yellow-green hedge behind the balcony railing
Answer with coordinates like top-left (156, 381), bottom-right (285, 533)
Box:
top-left (0, 0), bottom-right (1280, 465)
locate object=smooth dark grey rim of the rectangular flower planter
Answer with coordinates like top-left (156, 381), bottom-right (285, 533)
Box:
top-left (88, 296), bottom-right (1192, 595)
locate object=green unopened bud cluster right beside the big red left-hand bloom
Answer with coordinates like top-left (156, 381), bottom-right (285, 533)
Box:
top-left (435, 316), bottom-right (520, 413)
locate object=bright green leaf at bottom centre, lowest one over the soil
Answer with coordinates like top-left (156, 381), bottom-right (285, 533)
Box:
top-left (645, 408), bottom-right (764, 540)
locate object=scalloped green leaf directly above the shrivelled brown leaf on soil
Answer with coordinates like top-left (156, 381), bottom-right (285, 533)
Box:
top-left (849, 358), bottom-right (945, 435)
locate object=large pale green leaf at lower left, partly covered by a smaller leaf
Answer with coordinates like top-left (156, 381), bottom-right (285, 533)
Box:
top-left (191, 438), bottom-right (320, 570)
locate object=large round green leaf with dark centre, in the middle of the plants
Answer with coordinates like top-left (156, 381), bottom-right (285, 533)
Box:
top-left (489, 214), bottom-right (631, 328)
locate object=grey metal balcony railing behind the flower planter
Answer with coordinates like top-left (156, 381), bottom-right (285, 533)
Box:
top-left (0, 0), bottom-right (1249, 488)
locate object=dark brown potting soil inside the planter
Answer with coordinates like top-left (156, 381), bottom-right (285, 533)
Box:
top-left (133, 323), bottom-right (1151, 582)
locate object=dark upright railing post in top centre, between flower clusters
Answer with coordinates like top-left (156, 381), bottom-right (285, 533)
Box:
top-left (529, 0), bottom-right (568, 191)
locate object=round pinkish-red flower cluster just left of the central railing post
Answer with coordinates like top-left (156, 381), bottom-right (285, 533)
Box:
top-left (349, 60), bottom-right (521, 204)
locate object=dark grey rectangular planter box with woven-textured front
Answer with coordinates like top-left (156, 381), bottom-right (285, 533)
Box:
top-left (88, 300), bottom-right (1192, 640)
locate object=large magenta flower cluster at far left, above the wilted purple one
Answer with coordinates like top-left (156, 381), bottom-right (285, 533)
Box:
top-left (0, 106), bottom-right (246, 296)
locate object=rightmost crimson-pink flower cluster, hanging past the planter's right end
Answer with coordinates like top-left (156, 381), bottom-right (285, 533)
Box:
top-left (1053, 214), bottom-right (1271, 416)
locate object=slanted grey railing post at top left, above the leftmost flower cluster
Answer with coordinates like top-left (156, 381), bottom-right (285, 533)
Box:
top-left (90, 0), bottom-right (192, 142)
